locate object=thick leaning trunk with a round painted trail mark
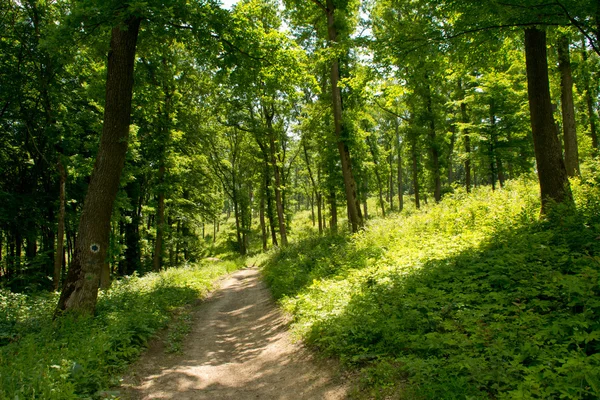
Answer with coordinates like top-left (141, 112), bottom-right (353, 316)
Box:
top-left (57, 17), bottom-right (141, 314)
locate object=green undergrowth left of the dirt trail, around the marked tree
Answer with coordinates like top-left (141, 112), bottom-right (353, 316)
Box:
top-left (0, 259), bottom-right (244, 400)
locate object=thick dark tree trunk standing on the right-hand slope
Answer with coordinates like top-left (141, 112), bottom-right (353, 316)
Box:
top-left (525, 28), bottom-right (572, 213)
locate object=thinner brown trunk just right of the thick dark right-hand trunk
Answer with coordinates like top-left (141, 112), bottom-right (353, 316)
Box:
top-left (558, 36), bottom-right (579, 176)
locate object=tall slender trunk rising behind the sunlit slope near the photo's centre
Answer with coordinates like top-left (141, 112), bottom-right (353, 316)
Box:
top-left (326, 0), bottom-right (363, 232)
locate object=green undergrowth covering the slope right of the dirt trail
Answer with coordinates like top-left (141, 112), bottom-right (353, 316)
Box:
top-left (263, 180), bottom-right (600, 399)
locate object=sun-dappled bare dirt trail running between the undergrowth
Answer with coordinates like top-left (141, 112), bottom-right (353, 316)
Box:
top-left (123, 268), bottom-right (348, 400)
